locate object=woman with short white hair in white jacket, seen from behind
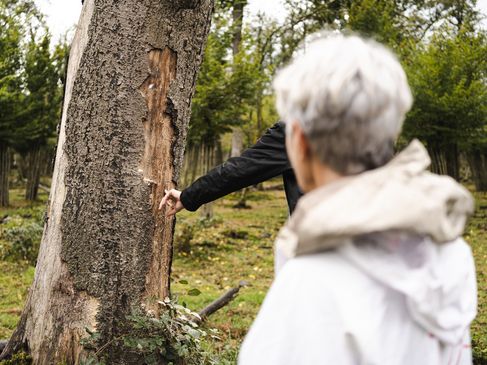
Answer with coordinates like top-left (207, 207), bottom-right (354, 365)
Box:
top-left (239, 35), bottom-right (476, 365)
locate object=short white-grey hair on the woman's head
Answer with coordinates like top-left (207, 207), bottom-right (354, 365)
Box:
top-left (274, 33), bottom-right (412, 175)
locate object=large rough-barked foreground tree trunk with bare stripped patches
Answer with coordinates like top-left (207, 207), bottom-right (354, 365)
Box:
top-left (2, 0), bottom-right (213, 364)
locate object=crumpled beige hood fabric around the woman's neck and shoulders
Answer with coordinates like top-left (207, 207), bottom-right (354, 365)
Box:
top-left (276, 140), bottom-right (474, 266)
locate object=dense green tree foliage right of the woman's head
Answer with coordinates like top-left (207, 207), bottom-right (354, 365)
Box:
top-left (404, 28), bottom-right (487, 151)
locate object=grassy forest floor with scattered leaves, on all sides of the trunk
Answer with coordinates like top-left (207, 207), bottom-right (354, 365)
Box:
top-left (0, 183), bottom-right (487, 364)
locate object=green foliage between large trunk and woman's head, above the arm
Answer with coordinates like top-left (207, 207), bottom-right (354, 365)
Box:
top-left (188, 0), bottom-right (279, 154)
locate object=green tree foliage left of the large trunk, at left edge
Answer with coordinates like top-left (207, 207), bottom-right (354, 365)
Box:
top-left (0, 0), bottom-right (66, 154)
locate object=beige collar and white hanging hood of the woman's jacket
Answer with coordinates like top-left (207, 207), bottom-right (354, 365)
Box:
top-left (276, 141), bottom-right (476, 343)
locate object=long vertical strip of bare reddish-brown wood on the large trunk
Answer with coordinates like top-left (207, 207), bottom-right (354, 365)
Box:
top-left (139, 47), bottom-right (177, 307)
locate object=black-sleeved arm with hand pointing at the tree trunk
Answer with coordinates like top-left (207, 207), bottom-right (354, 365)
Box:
top-left (159, 122), bottom-right (302, 216)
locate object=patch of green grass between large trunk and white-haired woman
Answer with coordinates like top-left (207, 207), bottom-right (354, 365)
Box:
top-left (172, 191), bottom-right (287, 347)
